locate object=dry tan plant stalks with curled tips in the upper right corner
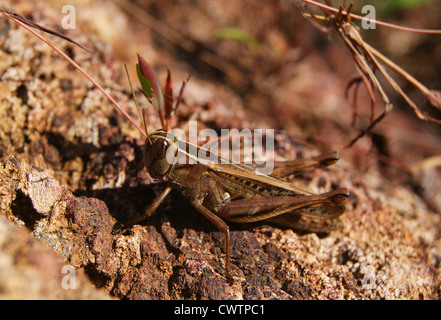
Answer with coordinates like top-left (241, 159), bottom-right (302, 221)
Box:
top-left (296, 0), bottom-right (441, 147)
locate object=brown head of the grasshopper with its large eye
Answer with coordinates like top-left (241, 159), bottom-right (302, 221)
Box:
top-left (144, 129), bottom-right (178, 180)
